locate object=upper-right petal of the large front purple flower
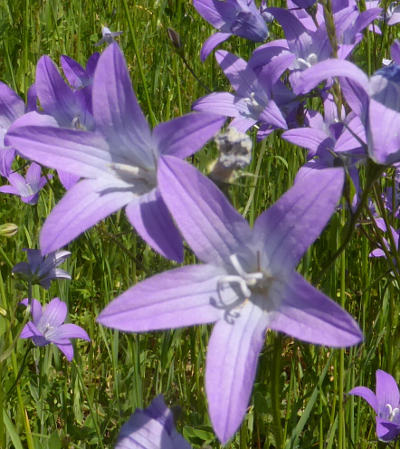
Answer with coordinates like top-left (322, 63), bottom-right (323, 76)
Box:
top-left (254, 167), bottom-right (344, 269)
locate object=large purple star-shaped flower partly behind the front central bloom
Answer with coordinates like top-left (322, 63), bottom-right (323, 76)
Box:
top-left (7, 44), bottom-right (225, 261)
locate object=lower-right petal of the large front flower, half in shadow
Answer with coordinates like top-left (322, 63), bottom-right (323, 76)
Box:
top-left (269, 272), bottom-right (363, 347)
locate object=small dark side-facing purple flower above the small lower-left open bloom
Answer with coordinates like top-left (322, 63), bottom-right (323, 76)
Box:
top-left (12, 249), bottom-right (71, 290)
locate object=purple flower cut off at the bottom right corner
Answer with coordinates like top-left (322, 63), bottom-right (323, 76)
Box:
top-left (349, 369), bottom-right (400, 442)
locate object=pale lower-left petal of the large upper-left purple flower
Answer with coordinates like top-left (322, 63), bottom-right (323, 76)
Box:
top-left (40, 179), bottom-right (134, 255)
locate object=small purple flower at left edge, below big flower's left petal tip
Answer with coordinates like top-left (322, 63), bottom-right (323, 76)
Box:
top-left (0, 162), bottom-right (52, 205)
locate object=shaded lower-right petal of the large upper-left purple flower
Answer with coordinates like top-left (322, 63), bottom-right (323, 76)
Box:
top-left (125, 189), bottom-right (183, 263)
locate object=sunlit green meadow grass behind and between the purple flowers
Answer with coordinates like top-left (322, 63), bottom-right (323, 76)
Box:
top-left (0, 0), bottom-right (400, 449)
